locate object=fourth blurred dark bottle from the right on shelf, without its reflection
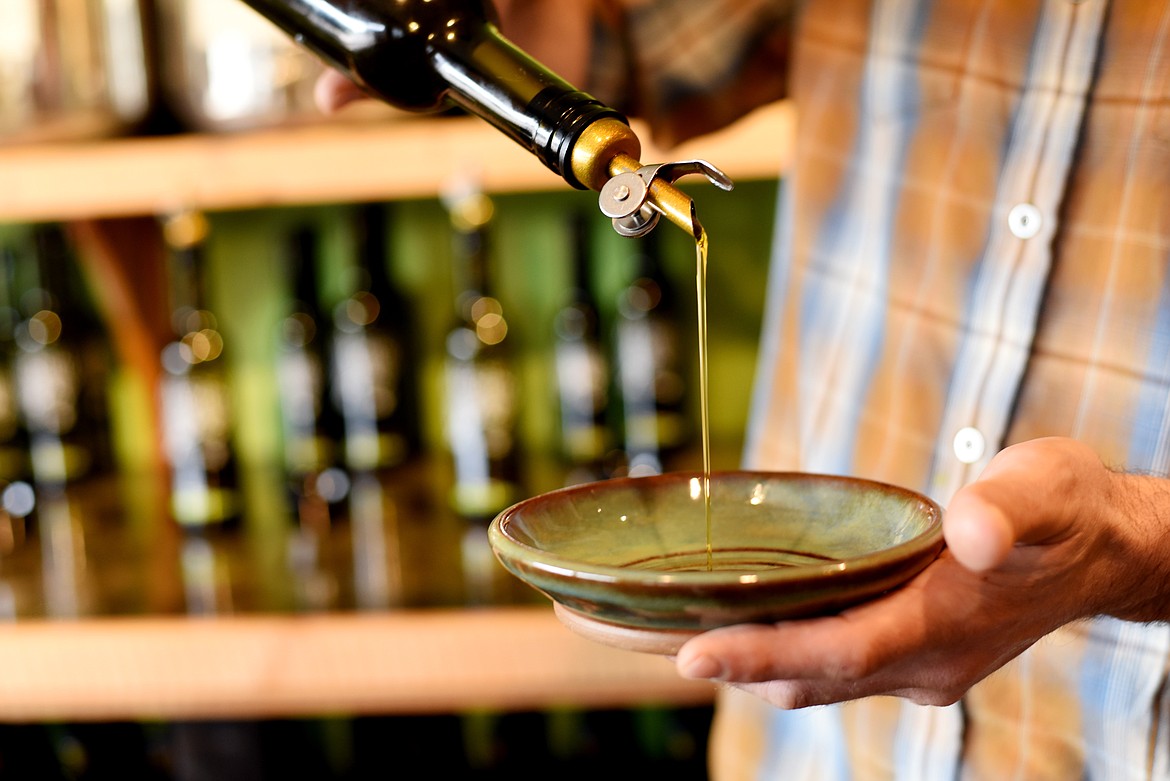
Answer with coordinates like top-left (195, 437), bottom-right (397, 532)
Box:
top-left (332, 203), bottom-right (420, 472)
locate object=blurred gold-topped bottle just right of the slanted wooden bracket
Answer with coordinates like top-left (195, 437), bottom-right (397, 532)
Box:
top-left (160, 212), bottom-right (240, 530)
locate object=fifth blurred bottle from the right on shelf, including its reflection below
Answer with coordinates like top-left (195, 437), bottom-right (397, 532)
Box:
top-left (276, 226), bottom-right (341, 610)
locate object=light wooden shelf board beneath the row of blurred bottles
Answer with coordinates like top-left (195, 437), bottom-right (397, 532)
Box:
top-left (0, 607), bottom-right (714, 721)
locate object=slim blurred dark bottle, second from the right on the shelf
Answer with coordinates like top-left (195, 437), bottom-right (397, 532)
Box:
top-left (553, 214), bottom-right (613, 484)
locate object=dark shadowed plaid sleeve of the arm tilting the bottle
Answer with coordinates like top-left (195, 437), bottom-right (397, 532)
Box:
top-left (589, 0), bottom-right (797, 146)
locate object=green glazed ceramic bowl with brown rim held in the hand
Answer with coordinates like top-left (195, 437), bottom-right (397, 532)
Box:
top-left (488, 471), bottom-right (943, 655)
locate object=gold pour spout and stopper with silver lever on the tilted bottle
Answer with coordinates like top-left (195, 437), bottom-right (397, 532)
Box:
top-left (572, 118), bottom-right (734, 241)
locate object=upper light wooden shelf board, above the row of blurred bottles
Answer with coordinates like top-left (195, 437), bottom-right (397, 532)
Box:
top-left (0, 103), bottom-right (793, 222)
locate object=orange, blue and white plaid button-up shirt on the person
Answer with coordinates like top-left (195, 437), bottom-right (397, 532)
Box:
top-left (599, 0), bottom-right (1170, 781)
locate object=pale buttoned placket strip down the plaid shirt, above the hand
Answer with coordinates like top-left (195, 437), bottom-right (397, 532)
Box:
top-left (929, 0), bottom-right (1106, 503)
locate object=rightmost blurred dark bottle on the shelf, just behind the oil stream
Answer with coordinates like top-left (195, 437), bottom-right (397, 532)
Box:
top-left (613, 231), bottom-right (689, 476)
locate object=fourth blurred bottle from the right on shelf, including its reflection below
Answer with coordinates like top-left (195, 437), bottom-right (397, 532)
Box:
top-left (332, 202), bottom-right (421, 609)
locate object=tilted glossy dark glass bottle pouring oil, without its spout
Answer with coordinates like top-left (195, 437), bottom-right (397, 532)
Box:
top-left (236, 0), bottom-right (625, 188)
